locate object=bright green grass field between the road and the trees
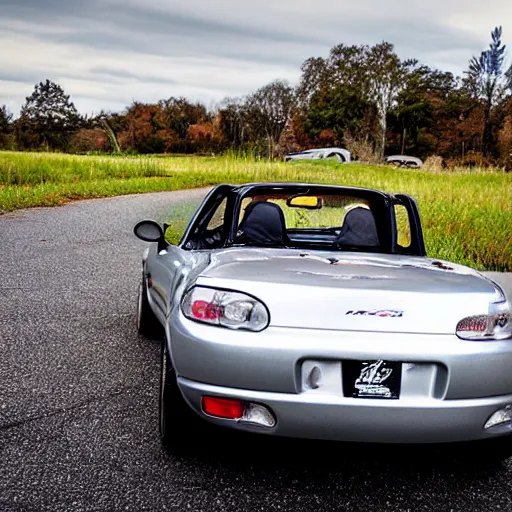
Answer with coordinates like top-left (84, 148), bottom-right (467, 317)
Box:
top-left (0, 152), bottom-right (512, 271)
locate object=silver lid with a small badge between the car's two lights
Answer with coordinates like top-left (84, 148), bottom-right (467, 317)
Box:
top-left (197, 248), bottom-right (497, 334)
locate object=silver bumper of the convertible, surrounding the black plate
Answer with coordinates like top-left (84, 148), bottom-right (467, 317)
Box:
top-left (168, 316), bottom-right (512, 443)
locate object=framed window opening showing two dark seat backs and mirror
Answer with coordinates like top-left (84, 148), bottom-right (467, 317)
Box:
top-left (234, 194), bottom-right (381, 251)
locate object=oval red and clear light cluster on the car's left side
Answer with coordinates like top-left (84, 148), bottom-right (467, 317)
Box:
top-left (181, 286), bottom-right (270, 331)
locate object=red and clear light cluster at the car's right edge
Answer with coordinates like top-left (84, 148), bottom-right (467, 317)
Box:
top-left (456, 290), bottom-right (512, 341)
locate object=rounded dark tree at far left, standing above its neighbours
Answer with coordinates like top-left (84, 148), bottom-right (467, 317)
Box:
top-left (16, 80), bottom-right (81, 150)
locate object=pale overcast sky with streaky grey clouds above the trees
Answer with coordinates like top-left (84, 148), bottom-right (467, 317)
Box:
top-left (0, 0), bottom-right (512, 116)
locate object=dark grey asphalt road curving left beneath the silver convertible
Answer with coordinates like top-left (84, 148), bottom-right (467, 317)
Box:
top-left (0, 190), bottom-right (512, 512)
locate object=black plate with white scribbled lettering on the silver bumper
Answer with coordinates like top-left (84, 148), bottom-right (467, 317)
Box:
top-left (343, 360), bottom-right (402, 399)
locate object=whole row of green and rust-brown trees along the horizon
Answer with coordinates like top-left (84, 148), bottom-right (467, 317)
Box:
top-left (0, 27), bottom-right (512, 169)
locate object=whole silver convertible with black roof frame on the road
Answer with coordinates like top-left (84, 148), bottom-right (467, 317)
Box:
top-left (134, 183), bottom-right (512, 459)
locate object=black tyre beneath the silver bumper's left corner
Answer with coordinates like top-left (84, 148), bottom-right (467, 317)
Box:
top-left (159, 340), bottom-right (213, 455)
